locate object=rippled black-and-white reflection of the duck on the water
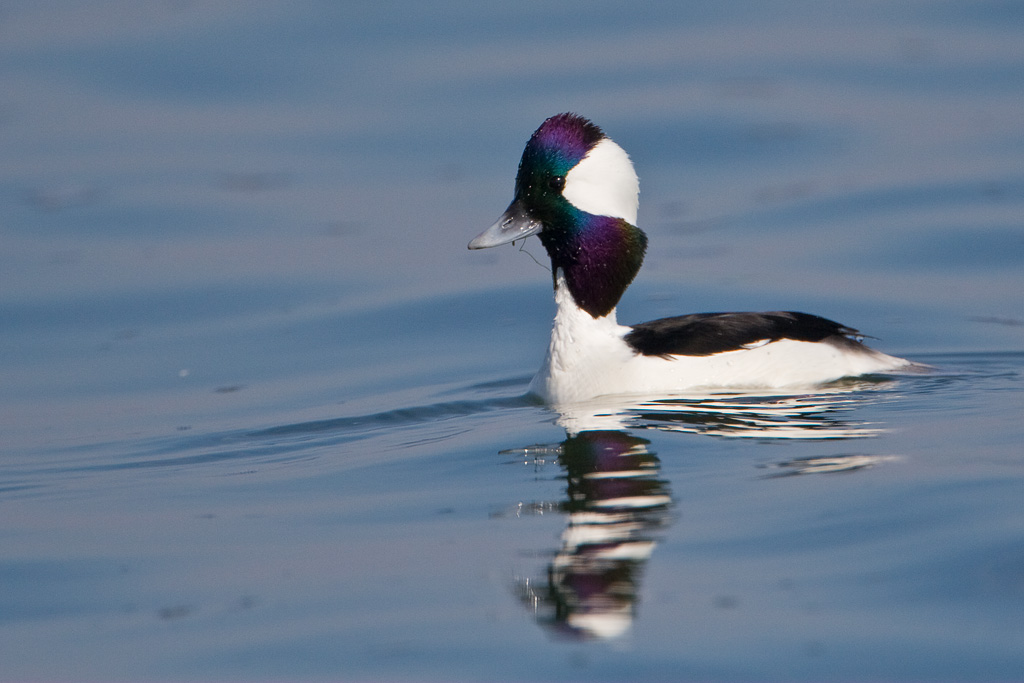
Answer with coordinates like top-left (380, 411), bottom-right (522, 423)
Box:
top-left (503, 384), bottom-right (887, 639)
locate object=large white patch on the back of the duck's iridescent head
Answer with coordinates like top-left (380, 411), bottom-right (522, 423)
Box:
top-left (562, 138), bottom-right (640, 225)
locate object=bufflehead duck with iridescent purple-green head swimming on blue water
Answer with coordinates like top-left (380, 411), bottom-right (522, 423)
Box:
top-left (469, 113), bottom-right (922, 404)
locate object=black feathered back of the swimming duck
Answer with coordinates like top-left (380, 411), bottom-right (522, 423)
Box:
top-left (626, 310), bottom-right (862, 355)
